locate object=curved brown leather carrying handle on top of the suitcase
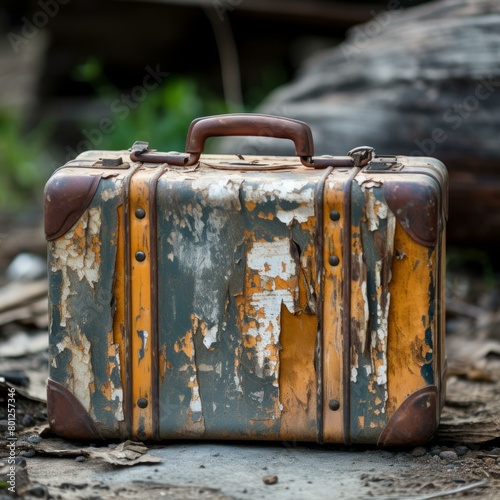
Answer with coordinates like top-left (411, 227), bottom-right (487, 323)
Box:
top-left (186, 113), bottom-right (314, 167)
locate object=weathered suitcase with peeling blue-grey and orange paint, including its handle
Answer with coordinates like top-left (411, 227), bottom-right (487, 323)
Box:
top-left (45, 114), bottom-right (447, 446)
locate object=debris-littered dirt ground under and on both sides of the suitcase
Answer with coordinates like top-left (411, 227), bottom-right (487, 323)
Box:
top-left (0, 218), bottom-right (500, 500)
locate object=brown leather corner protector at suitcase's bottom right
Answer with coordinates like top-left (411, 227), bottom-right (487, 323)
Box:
top-left (377, 385), bottom-right (439, 446)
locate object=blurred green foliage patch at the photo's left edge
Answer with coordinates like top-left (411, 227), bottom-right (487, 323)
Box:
top-left (0, 110), bottom-right (49, 213)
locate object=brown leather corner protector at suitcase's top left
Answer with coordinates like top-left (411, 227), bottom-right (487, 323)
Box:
top-left (45, 173), bottom-right (101, 241)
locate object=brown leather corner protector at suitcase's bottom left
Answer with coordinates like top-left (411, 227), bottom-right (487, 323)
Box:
top-left (47, 379), bottom-right (102, 440)
